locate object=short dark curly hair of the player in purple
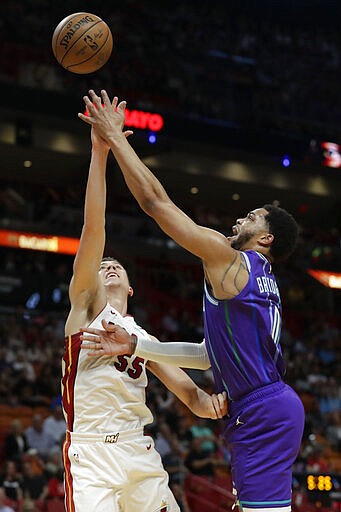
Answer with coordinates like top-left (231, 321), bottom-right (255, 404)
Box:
top-left (263, 204), bottom-right (298, 262)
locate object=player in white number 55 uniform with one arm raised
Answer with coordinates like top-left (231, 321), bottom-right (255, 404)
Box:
top-left (62, 128), bottom-right (226, 512)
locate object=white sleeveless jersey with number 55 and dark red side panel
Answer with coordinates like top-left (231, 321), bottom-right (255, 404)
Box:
top-left (62, 304), bottom-right (153, 434)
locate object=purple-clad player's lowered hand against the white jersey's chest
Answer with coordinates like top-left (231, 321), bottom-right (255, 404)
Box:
top-left (80, 320), bottom-right (135, 356)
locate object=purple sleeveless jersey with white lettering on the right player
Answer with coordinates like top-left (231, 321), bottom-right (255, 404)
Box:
top-left (203, 251), bottom-right (285, 400)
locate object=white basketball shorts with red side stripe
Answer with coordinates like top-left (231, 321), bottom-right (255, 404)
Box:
top-left (63, 429), bottom-right (180, 512)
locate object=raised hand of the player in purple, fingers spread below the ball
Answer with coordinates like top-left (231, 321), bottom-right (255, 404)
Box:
top-left (78, 90), bottom-right (133, 141)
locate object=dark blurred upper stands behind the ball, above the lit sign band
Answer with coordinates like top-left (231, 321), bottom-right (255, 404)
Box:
top-left (0, 0), bottom-right (341, 137)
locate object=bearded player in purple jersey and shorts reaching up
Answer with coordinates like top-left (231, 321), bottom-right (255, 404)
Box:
top-left (79, 91), bottom-right (304, 512)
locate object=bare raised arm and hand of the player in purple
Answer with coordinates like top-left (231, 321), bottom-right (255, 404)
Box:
top-left (79, 91), bottom-right (236, 264)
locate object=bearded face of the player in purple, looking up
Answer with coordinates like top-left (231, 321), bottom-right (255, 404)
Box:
top-left (228, 208), bottom-right (269, 250)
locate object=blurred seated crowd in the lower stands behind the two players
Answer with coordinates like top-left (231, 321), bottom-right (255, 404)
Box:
top-left (0, 186), bottom-right (341, 512)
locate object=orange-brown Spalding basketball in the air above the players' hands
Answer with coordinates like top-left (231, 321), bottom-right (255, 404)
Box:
top-left (52, 12), bottom-right (113, 74)
